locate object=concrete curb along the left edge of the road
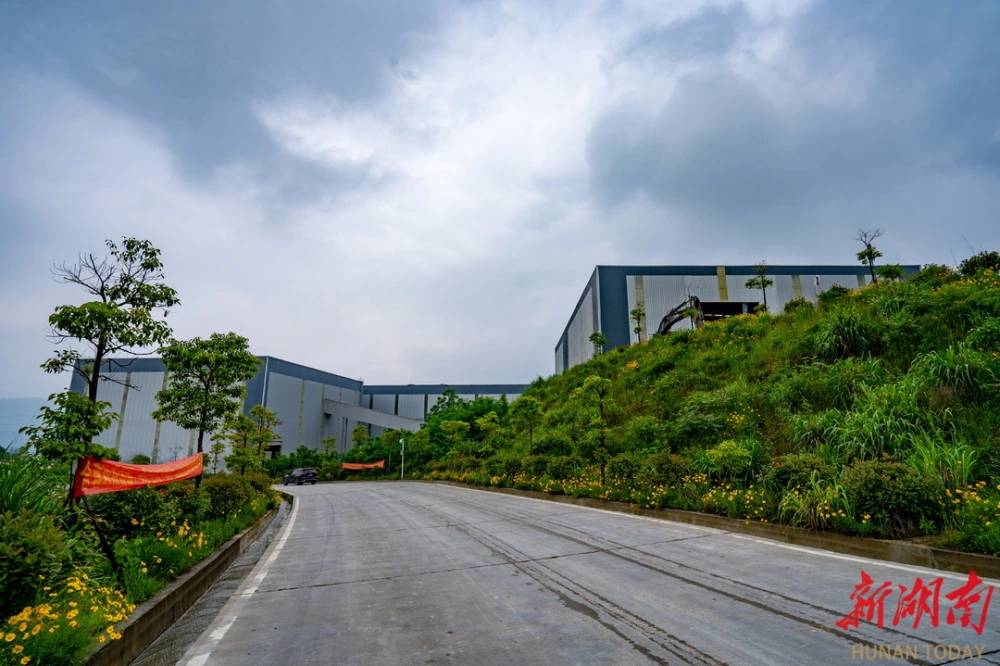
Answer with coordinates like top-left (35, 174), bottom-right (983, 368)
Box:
top-left (86, 508), bottom-right (278, 666)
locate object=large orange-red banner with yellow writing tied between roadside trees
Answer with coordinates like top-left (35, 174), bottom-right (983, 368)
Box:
top-left (73, 453), bottom-right (202, 497)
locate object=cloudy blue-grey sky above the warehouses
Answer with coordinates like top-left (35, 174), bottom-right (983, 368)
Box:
top-left (0, 0), bottom-right (1000, 397)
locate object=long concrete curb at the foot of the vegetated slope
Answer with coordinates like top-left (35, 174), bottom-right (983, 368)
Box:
top-left (425, 481), bottom-right (1000, 579)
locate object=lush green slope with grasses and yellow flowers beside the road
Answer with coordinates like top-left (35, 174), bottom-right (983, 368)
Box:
top-left (412, 265), bottom-right (1000, 554)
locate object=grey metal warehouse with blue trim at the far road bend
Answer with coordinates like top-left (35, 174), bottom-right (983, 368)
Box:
top-left (70, 356), bottom-right (527, 463)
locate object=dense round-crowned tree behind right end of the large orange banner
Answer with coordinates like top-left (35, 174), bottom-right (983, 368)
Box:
top-left (153, 333), bottom-right (260, 485)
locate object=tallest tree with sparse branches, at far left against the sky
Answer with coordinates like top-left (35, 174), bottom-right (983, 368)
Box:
top-left (42, 238), bottom-right (180, 401)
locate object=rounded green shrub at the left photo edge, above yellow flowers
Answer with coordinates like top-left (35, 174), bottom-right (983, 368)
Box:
top-left (0, 509), bottom-right (71, 618)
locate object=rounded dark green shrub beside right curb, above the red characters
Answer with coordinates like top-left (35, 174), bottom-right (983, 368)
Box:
top-left (840, 460), bottom-right (944, 538)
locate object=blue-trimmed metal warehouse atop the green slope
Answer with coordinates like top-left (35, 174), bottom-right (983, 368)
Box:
top-left (555, 264), bottom-right (920, 373)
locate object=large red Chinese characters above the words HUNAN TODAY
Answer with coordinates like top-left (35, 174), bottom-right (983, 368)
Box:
top-left (837, 571), bottom-right (993, 635)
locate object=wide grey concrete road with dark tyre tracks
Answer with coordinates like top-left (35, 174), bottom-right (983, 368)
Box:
top-left (181, 482), bottom-right (1000, 666)
